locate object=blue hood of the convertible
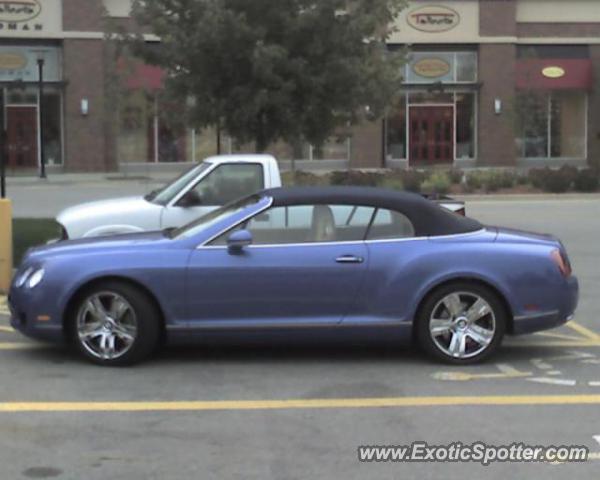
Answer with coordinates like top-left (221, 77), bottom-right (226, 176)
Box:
top-left (25, 232), bottom-right (173, 261)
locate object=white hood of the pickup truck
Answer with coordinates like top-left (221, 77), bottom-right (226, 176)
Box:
top-left (56, 196), bottom-right (162, 226)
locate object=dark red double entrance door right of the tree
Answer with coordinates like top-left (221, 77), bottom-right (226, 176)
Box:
top-left (409, 107), bottom-right (454, 165)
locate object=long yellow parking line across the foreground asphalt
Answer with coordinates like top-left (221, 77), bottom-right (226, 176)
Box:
top-left (0, 395), bottom-right (600, 413)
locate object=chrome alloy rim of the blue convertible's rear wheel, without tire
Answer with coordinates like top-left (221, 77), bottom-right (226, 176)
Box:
top-left (429, 292), bottom-right (496, 359)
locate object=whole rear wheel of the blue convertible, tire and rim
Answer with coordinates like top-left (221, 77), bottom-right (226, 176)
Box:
top-left (416, 283), bottom-right (507, 365)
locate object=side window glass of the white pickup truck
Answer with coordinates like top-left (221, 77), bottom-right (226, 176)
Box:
top-left (189, 163), bottom-right (264, 206)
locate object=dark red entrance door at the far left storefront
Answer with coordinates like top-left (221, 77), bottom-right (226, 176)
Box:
top-left (6, 107), bottom-right (38, 168)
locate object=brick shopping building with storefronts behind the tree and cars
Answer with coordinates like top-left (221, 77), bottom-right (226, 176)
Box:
top-left (0, 0), bottom-right (600, 173)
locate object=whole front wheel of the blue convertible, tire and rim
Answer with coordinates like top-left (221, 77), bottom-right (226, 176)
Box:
top-left (69, 282), bottom-right (160, 366)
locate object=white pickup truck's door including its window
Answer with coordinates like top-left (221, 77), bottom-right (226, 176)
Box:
top-left (161, 162), bottom-right (264, 229)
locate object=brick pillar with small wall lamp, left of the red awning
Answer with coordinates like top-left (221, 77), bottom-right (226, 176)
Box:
top-left (478, 44), bottom-right (517, 166)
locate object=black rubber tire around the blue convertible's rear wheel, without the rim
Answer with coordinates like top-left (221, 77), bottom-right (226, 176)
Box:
top-left (415, 282), bottom-right (508, 365)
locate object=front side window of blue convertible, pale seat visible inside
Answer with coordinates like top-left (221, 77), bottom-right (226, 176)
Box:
top-left (212, 205), bottom-right (375, 245)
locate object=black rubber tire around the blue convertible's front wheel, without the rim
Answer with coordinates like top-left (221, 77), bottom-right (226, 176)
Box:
top-left (67, 281), bottom-right (161, 367)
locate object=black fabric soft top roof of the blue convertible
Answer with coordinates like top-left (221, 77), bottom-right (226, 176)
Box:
top-left (261, 187), bottom-right (483, 237)
